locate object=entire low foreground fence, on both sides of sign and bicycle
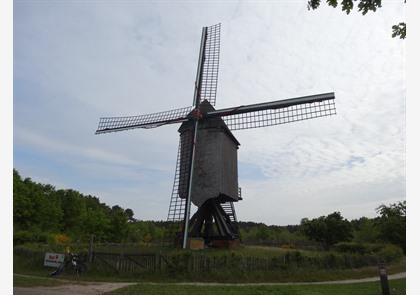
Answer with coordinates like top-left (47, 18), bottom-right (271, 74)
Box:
top-left (14, 247), bottom-right (398, 274)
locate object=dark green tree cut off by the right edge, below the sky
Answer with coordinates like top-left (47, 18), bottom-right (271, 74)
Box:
top-left (376, 201), bottom-right (406, 252)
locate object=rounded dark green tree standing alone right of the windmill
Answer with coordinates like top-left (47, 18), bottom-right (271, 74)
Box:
top-left (301, 212), bottom-right (352, 250)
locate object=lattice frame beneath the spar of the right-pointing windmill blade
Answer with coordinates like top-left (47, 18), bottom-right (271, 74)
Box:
top-left (222, 99), bottom-right (336, 130)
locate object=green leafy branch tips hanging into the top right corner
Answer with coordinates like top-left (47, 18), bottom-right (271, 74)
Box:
top-left (308, 0), bottom-right (406, 39)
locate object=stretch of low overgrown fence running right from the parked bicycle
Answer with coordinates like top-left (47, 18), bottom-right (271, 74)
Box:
top-left (92, 251), bottom-right (378, 273)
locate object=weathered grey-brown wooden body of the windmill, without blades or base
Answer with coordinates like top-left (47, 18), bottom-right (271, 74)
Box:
top-left (178, 100), bottom-right (239, 207)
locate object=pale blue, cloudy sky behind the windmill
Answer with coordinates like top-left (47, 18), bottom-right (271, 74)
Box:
top-left (13, 0), bottom-right (406, 225)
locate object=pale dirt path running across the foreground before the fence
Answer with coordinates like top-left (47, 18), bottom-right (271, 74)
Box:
top-left (13, 272), bottom-right (405, 295)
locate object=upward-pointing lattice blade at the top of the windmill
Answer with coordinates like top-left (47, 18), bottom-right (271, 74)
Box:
top-left (198, 23), bottom-right (221, 106)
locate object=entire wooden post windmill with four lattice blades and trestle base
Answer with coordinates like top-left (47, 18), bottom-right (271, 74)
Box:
top-left (95, 24), bottom-right (336, 248)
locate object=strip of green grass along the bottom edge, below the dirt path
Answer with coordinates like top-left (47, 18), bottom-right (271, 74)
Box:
top-left (107, 279), bottom-right (405, 295)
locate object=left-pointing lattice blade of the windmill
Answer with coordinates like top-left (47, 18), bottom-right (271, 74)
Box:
top-left (95, 107), bottom-right (193, 134)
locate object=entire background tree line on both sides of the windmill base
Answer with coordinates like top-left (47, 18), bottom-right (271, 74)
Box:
top-left (13, 170), bottom-right (406, 251)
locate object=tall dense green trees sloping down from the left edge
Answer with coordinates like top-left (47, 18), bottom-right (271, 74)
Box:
top-left (13, 170), bottom-right (133, 244)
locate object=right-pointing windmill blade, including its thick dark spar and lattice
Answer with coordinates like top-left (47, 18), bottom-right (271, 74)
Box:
top-left (206, 93), bottom-right (336, 130)
